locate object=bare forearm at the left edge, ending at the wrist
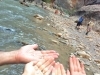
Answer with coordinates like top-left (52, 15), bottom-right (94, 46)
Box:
top-left (0, 51), bottom-right (17, 65)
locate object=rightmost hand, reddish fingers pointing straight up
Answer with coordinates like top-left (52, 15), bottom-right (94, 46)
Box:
top-left (69, 56), bottom-right (86, 75)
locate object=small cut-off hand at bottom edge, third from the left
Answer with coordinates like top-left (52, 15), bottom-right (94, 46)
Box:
top-left (52, 62), bottom-right (66, 75)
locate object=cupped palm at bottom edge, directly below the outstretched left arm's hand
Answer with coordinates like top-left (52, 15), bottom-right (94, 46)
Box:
top-left (23, 58), bottom-right (55, 75)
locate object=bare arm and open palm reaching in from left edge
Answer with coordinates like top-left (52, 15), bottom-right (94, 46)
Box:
top-left (0, 44), bottom-right (59, 65)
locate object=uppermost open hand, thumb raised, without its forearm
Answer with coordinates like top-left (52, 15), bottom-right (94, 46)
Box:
top-left (15, 44), bottom-right (59, 63)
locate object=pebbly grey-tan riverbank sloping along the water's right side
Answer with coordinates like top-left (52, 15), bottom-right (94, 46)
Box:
top-left (45, 6), bottom-right (100, 75)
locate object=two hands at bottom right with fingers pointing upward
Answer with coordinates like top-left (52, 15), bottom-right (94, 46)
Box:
top-left (52, 56), bottom-right (86, 75)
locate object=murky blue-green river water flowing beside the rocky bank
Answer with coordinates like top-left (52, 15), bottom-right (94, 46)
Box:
top-left (0, 0), bottom-right (73, 75)
